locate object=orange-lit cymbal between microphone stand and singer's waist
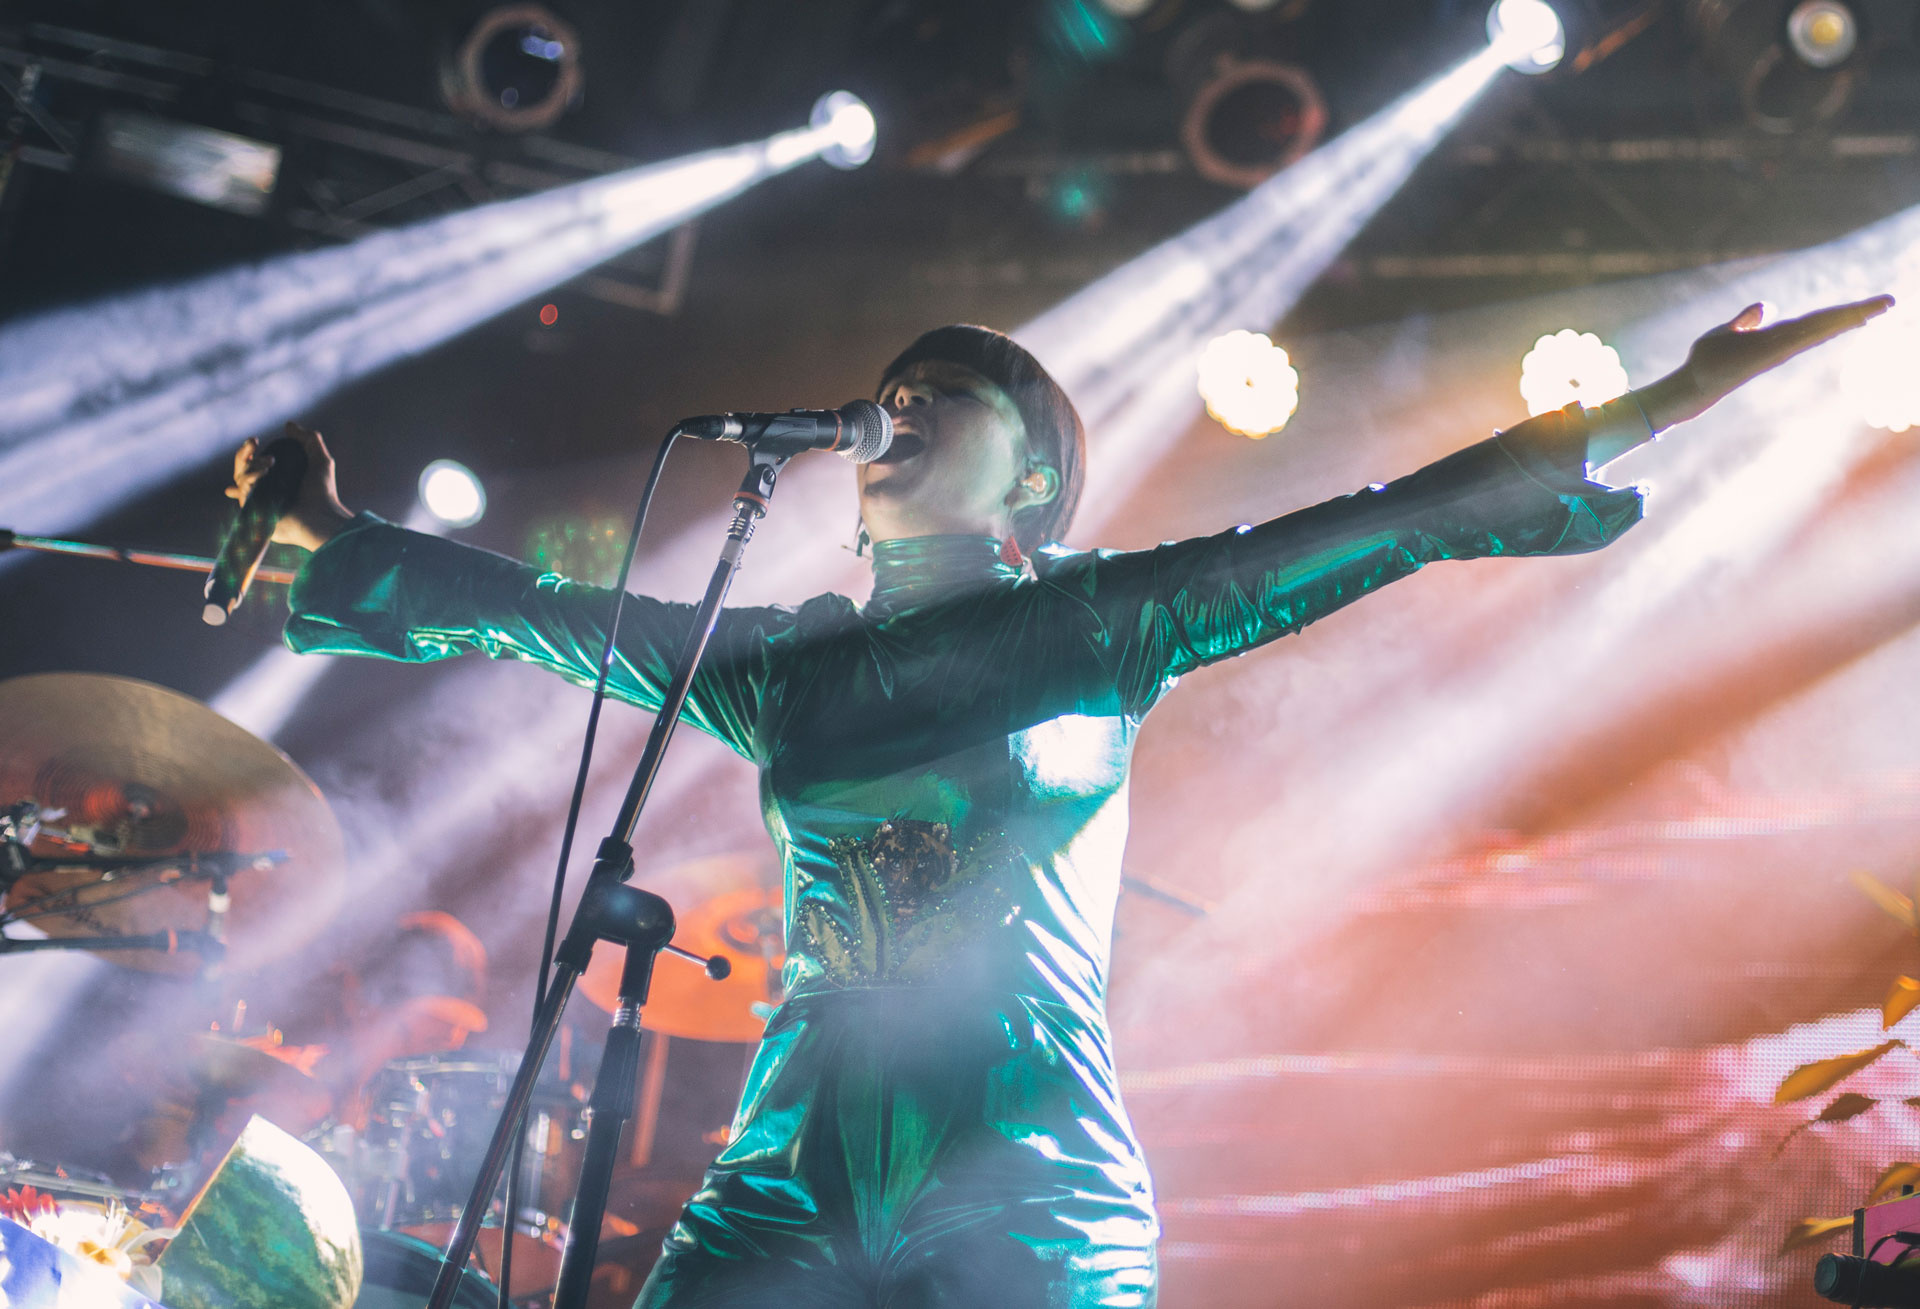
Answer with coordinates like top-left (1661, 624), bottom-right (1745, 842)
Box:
top-left (580, 858), bottom-right (785, 1042)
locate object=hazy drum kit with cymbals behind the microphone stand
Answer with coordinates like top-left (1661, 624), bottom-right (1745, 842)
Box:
top-left (0, 674), bottom-right (781, 1309)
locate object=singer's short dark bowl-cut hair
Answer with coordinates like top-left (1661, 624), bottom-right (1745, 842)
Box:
top-left (879, 322), bottom-right (1087, 555)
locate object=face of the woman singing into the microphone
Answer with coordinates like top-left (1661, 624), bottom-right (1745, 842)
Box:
top-left (858, 359), bottom-right (1060, 541)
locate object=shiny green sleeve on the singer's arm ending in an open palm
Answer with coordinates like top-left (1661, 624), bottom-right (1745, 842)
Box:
top-left (1046, 413), bottom-right (1642, 714)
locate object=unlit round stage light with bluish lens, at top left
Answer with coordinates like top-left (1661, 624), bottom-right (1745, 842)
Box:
top-left (440, 4), bottom-right (584, 132)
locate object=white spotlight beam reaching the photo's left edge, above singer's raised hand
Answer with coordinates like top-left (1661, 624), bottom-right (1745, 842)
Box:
top-left (0, 101), bottom-right (871, 532)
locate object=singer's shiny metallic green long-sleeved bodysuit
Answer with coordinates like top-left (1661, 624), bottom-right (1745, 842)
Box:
top-left (288, 415), bottom-right (1640, 1309)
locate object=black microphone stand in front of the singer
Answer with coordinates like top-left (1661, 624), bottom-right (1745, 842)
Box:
top-left (428, 447), bottom-right (791, 1309)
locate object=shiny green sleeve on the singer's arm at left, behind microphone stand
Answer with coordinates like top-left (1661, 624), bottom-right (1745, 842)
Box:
top-left (286, 514), bottom-right (791, 758)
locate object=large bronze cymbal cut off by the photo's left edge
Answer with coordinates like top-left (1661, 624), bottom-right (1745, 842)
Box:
top-left (0, 674), bottom-right (346, 973)
